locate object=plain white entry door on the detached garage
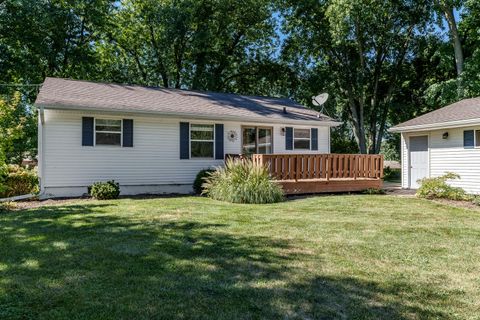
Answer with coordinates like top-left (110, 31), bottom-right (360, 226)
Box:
top-left (410, 136), bottom-right (428, 189)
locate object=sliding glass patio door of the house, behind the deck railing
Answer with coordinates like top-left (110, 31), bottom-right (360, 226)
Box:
top-left (242, 127), bottom-right (273, 155)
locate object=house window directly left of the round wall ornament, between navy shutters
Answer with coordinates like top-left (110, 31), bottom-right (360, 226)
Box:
top-left (190, 124), bottom-right (215, 158)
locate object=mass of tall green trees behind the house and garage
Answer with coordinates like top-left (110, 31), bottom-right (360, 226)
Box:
top-left (0, 0), bottom-right (480, 162)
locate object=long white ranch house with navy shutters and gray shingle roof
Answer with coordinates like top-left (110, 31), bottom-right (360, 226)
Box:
top-left (35, 78), bottom-right (340, 197)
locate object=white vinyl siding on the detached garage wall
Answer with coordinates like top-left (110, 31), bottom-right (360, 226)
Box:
top-left (402, 125), bottom-right (480, 194)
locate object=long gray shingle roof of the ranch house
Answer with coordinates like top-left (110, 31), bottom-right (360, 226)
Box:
top-left (35, 78), bottom-right (338, 125)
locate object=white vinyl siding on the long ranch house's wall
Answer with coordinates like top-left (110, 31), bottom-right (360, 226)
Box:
top-left (42, 110), bottom-right (329, 195)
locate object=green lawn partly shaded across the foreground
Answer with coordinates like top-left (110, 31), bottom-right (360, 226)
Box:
top-left (0, 195), bottom-right (480, 319)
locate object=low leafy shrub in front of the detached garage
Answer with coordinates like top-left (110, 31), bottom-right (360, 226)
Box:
top-left (417, 172), bottom-right (471, 200)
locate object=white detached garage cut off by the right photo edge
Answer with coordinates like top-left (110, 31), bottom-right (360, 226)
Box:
top-left (390, 97), bottom-right (480, 194)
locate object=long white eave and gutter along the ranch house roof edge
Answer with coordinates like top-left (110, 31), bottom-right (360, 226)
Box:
top-left (35, 103), bottom-right (342, 127)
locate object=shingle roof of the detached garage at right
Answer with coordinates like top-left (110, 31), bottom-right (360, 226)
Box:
top-left (391, 97), bottom-right (480, 131)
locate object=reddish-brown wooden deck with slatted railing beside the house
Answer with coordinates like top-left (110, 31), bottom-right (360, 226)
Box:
top-left (252, 154), bottom-right (383, 194)
